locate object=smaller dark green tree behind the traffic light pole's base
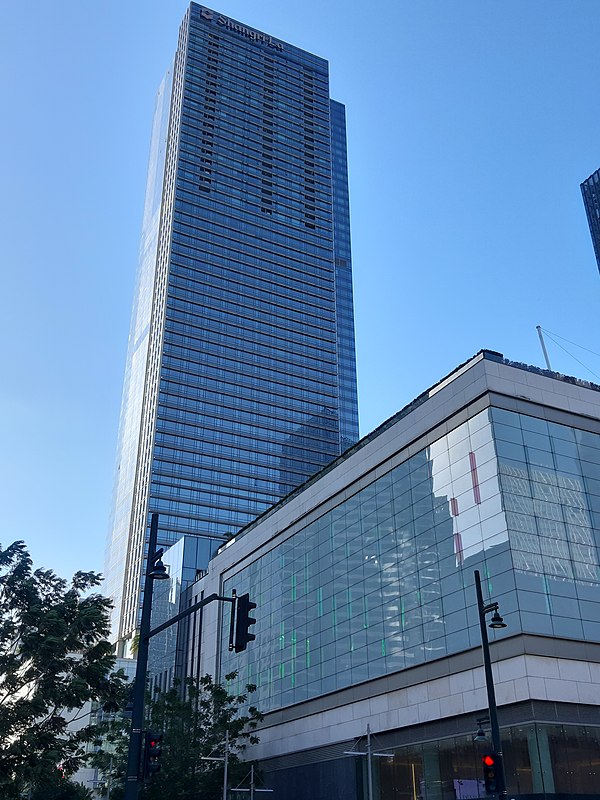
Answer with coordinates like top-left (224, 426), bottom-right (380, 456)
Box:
top-left (92, 673), bottom-right (262, 800)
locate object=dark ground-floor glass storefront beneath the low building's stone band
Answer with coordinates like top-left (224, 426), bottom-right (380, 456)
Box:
top-left (261, 723), bottom-right (600, 800)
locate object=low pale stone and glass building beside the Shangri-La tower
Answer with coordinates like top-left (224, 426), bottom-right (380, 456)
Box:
top-left (185, 351), bottom-right (600, 800)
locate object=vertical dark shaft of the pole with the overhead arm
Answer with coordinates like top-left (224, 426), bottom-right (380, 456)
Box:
top-left (124, 514), bottom-right (158, 800)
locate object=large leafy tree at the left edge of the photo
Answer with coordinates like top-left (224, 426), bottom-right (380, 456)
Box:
top-left (0, 542), bottom-right (125, 800)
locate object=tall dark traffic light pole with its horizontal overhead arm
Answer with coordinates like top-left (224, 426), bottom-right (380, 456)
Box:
top-left (124, 514), bottom-right (236, 800)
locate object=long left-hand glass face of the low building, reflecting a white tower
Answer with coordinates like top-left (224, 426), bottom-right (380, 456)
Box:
top-left (221, 412), bottom-right (504, 711)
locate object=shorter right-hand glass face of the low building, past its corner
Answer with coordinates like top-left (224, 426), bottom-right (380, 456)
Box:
top-left (492, 408), bottom-right (600, 641)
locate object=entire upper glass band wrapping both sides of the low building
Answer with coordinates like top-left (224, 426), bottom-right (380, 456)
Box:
top-left (221, 409), bottom-right (600, 711)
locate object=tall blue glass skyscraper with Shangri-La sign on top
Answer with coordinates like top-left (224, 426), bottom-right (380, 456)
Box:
top-left (106, 3), bottom-right (358, 640)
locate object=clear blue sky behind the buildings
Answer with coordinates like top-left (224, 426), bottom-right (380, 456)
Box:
top-left (0, 0), bottom-right (600, 576)
